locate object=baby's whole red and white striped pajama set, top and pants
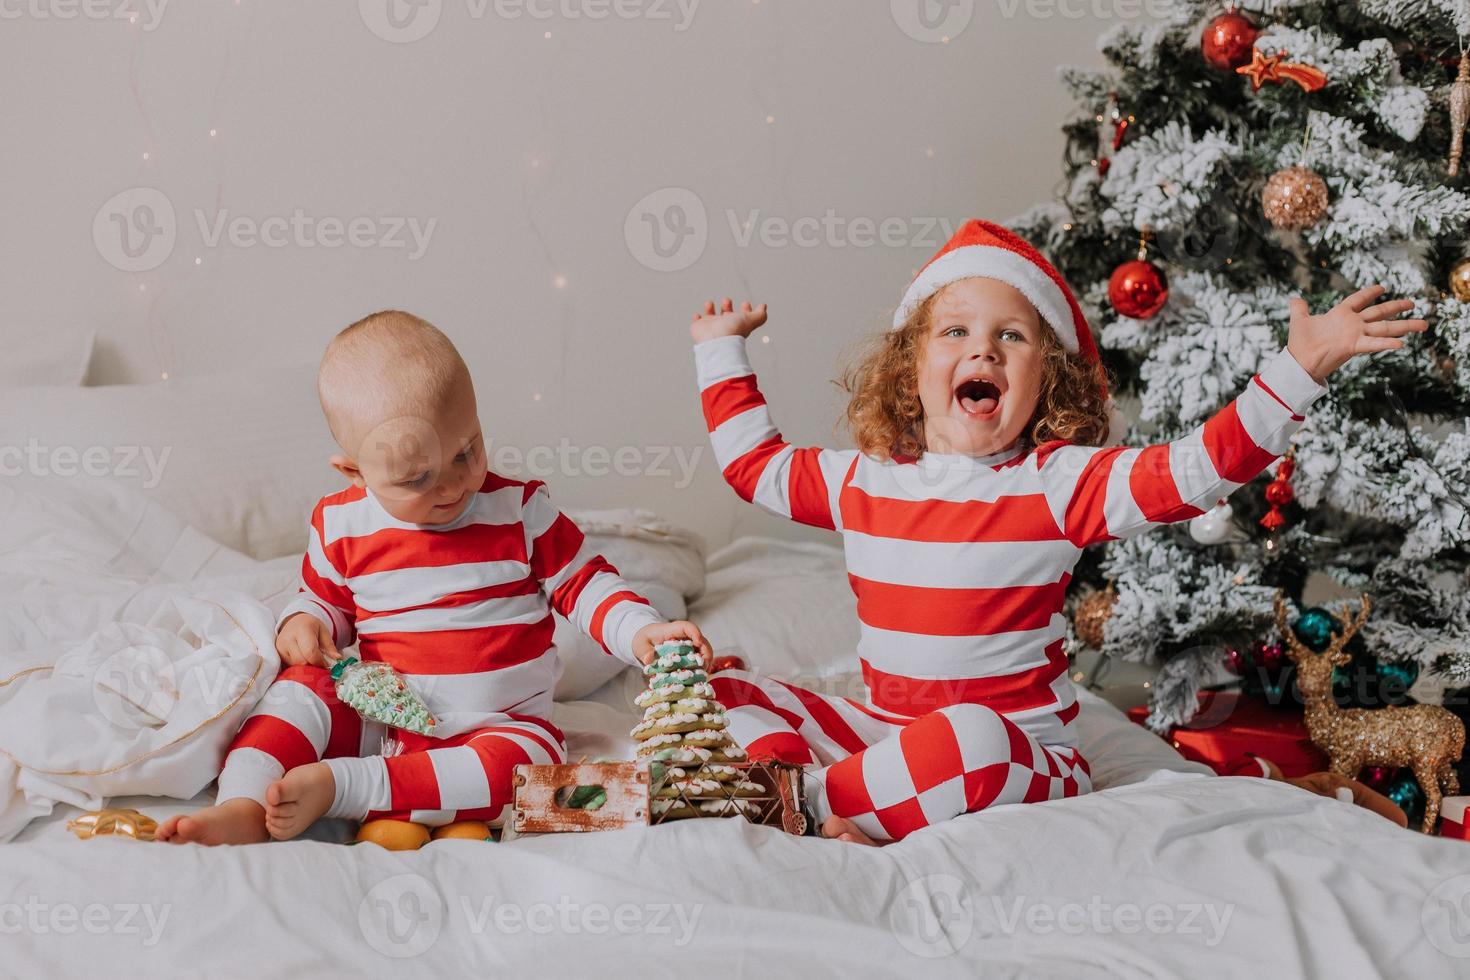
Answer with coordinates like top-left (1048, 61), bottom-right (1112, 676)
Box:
top-left (218, 473), bottom-right (662, 826)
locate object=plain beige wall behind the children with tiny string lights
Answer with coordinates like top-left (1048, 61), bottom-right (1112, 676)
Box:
top-left (0, 0), bottom-right (1132, 544)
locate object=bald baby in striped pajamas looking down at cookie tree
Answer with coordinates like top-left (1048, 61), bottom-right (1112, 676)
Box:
top-left (157, 311), bottom-right (710, 843)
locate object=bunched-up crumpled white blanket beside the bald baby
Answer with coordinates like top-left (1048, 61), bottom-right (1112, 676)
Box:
top-left (0, 586), bottom-right (281, 840)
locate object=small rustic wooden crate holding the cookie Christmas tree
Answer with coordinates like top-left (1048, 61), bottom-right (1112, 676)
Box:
top-left (512, 763), bottom-right (807, 836)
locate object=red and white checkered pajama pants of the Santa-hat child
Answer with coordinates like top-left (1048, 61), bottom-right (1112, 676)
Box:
top-left (710, 670), bottom-right (1092, 840)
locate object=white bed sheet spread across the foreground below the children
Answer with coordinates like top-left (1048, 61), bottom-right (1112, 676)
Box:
top-left (0, 487), bottom-right (1470, 977)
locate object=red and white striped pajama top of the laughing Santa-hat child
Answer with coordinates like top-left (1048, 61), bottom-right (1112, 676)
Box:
top-left (694, 336), bottom-right (1327, 748)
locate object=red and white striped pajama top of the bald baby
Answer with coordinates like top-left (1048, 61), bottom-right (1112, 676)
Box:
top-left (281, 473), bottom-right (663, 738)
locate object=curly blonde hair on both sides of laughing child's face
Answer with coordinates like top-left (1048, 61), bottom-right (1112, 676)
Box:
top-left (838, 292), bottom-right (1113, 460)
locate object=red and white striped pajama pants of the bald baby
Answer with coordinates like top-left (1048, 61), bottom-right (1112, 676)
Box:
top-left (218, 666), bottom-right (566, 827)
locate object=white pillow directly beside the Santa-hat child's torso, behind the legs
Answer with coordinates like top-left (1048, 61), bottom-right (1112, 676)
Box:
top-left (689, 538), bottom-right (861, 698)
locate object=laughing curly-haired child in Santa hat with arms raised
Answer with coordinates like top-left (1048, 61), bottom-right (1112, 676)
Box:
top-left (691, 220), bottom-right (1426, 843)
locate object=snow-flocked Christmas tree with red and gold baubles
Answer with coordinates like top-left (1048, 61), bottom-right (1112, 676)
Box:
top-left (1011, 0), bottom-right (1470, 727)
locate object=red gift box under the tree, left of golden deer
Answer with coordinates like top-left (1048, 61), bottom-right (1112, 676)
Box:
top-left (1127, 691), bottom-right (1327, 779)
